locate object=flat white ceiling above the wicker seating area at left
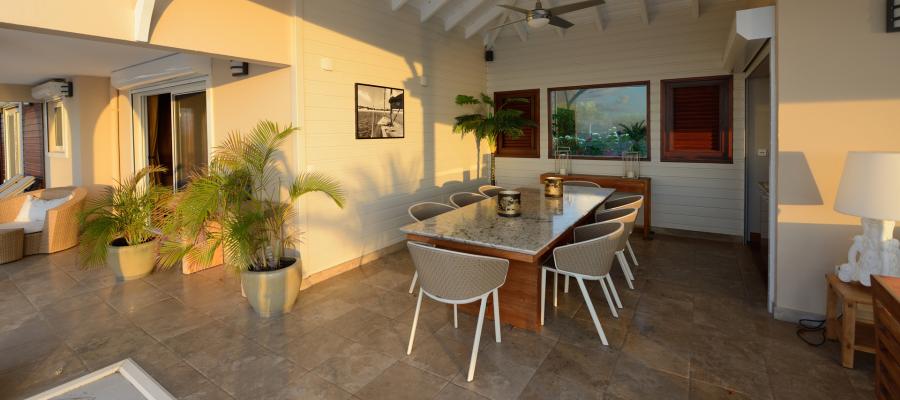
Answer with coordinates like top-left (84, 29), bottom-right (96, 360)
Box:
top-left (0, 28), bottom-right (172, 85)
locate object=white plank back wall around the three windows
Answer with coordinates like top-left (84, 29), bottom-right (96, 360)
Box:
top-left (487, 2), bottom-right (745, 235)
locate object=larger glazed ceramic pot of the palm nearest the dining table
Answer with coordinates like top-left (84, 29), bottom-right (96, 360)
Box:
top-left (241, 258), bottom-right (302, 317)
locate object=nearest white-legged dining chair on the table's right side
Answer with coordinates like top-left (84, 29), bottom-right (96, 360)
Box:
top-left (541, 222), bottom-right (625, 346)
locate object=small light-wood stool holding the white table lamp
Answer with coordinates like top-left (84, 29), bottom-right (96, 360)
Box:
top-left (825, 274), bottom-right (875, 368)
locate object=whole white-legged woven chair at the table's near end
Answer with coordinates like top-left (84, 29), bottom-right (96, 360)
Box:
top-left (406, 242), bottom-right (509, 382)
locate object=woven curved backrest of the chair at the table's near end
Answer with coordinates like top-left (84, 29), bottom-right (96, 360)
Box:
top-left (407, 242), bottom-right (509, 301)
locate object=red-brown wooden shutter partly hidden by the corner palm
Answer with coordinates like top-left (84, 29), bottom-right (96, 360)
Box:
top-left (494, 89), bottom-right (541, 158)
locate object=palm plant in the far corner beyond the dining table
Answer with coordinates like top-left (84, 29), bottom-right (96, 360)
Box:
top-left (453, 93), bottom-right (535, 185)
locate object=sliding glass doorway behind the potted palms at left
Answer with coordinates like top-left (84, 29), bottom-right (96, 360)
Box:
top-left (132, 82), bottom-right (209, 190)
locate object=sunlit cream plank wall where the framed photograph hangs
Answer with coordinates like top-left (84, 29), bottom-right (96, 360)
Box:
top-left (299, 0), bottom-right (485, 275)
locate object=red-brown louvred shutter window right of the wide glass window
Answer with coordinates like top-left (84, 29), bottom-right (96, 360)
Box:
top-left (661, 76), bottom-right (732, 163)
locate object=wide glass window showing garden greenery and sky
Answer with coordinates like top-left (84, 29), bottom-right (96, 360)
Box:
top-left (547, 82), bottom-right (650, 160)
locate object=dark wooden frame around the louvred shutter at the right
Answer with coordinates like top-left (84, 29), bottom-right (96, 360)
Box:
top-left (659, 75), bottom-right (734, 164)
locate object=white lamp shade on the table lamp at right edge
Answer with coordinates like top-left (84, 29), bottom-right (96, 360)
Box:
top-left (834, 151), bottom-right (900, 221)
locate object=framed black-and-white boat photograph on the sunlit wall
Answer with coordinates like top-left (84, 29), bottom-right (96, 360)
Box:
top-left (356, 83), bottom-right (404, 139)
